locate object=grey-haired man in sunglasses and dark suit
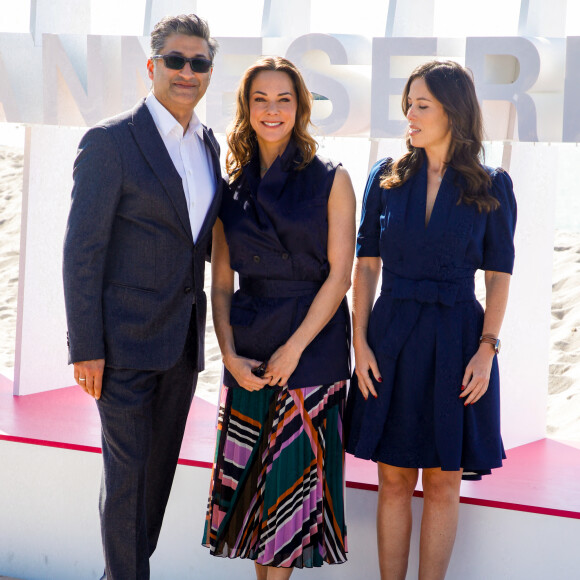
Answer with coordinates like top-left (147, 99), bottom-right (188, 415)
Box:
top-left (63, 14), bottom-right (223, 580)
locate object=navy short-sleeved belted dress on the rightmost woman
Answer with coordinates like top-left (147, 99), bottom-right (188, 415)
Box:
top-left (345, 159), bottom-right (516, 479)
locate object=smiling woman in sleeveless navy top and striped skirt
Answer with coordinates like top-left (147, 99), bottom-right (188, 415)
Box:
top-left (203, 58), bottom-right (355, 580)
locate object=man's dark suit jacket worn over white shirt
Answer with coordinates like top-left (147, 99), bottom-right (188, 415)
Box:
top-left (63, 101), bottom-right (224, 371)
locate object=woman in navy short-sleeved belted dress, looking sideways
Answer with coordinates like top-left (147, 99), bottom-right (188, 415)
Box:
top-left (346, 62), bottom-right (516, 580)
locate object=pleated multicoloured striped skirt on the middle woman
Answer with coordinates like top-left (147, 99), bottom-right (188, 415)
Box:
top-left (202, 381), bottom-right (347, 568)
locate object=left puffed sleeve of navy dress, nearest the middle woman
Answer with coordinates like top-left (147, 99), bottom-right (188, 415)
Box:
top-left (356, 159), bottom-right (391, 258)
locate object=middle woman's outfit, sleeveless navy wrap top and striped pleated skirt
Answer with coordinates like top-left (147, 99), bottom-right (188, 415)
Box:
top-left (202, 142), bottom-right (350, 568)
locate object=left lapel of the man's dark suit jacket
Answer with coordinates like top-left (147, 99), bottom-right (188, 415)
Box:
top-left (129, 101), bottom-right (193, 243)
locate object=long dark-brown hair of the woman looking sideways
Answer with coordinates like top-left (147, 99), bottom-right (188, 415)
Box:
top-left (380, 61), bottom-right (499, 212)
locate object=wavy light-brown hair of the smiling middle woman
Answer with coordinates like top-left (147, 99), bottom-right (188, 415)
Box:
top-left (226, 56), bottom-right (318, 181)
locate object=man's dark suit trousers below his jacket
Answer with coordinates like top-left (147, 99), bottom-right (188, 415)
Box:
top-left (97, 308), bottom-right (197, 580)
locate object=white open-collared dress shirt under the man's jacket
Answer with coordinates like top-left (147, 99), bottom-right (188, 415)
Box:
top-left (145, 93), bottom-right (216, 242)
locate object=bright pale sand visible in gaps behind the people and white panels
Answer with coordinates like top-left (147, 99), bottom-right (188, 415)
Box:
top-left (0, 147), bottom-right (580, 441)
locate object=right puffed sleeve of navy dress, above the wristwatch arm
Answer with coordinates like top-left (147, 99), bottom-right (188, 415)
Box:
top-left (481, 169), bottom-right (517, 274)
